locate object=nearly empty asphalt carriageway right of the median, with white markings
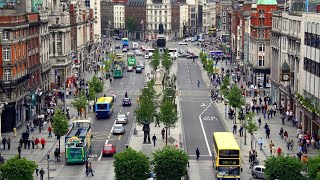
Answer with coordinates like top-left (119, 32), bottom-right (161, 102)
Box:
top-left (176, 43), bottom-right (226, 160)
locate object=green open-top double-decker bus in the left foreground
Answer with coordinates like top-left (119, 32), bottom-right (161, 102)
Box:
top-left (65, 120), bottom-right (92, 164)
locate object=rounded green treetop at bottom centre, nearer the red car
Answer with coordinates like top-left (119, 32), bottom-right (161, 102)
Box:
top-left (113, 147), bottom-right (150, 180)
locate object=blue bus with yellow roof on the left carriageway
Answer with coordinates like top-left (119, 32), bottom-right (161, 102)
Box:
top-left (95, 97), bottom-right (113, 119)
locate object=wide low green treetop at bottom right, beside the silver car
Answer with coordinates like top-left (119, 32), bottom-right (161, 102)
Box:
top-left (264, 156), bottom-right (305, 180)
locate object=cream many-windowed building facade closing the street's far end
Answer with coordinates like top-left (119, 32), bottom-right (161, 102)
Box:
top-left (145, 0), bottom-right (172, 40)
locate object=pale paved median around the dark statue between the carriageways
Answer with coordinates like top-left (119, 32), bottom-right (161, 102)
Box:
top-left (128, 61), bottom-right (183, 157)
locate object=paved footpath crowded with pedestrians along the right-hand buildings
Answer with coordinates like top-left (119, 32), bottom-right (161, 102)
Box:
top-left (194, 46), bottom-right (318, 178)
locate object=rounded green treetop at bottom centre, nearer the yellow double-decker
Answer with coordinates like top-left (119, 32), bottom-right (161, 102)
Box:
top-left (153, 146), bottom-right (189, 180)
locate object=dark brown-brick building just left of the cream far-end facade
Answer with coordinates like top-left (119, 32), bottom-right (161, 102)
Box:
top-left (125, 0), bottom-right (146, 40)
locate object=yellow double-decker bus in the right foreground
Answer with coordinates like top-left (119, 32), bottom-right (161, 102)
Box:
top-left (212, 132), bottom-right (242, 180)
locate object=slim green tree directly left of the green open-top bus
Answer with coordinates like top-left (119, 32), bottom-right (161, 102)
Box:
top-left (52, 109), bottom-right (69, 152)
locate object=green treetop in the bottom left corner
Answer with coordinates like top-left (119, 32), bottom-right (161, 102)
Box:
top-left (0, 156), bottom-right (38, 180)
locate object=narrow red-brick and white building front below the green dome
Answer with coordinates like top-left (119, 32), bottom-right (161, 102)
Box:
top-left (248, 0), bottom-right (277, 88)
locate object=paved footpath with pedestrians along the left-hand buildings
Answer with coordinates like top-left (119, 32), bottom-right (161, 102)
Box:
top-left (0, 72), bottom-right (110, 179)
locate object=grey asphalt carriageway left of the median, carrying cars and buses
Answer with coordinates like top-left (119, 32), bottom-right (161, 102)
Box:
top-left (57, 42), bottom-right (145, 180)
